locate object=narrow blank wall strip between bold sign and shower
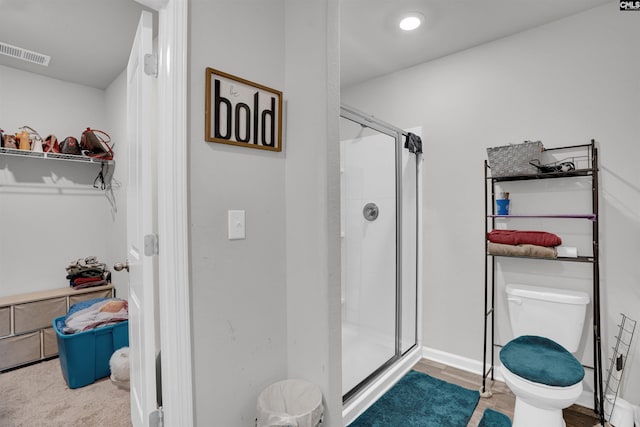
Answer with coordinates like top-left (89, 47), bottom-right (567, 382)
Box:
top-left (285, 0), bottom-right (342, 426)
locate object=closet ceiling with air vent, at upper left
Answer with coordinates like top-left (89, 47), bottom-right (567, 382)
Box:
top-left (0, 0), bottom-right (154, 89)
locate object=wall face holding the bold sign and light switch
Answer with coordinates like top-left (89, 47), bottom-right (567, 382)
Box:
top-left (189, 0), bottom-right (290, 426)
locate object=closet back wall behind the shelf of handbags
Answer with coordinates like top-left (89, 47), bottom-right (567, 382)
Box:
top-left (0, 67), bottom-right (126, 296)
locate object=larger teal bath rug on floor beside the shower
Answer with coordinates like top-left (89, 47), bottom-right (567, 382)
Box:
top-left (349, 371), bottom-right (480, 427)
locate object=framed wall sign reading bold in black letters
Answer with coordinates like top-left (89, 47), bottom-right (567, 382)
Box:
top-left (204, 68), bottom-right (282, 151)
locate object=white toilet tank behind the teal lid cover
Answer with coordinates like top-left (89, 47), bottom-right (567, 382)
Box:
top-left (506, 284), bottom-right (589, 353)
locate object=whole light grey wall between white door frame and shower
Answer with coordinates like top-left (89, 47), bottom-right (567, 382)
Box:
top-left (189, 0), bottom-right (341, 426)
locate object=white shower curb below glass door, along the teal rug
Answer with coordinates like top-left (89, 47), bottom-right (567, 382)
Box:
top-left (342, 347), bottom-right (422, 426)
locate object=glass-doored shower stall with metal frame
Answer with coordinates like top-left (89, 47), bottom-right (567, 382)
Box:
top-left (340, 105), bottom-right (421, 414)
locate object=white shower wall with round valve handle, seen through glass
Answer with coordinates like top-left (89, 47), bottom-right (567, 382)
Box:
top-left (341, 134), bottom-right (396, 342)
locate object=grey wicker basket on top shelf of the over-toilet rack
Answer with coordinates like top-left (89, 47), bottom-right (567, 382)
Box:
top-left (487, 141), bottom-right (544, 177)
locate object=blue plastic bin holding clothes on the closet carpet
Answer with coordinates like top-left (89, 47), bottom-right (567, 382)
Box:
top-left (53, 316), bottom-right (129, 388)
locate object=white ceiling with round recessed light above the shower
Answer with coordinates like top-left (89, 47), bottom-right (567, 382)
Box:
top-left (340, 0), bottom-right (618, 87)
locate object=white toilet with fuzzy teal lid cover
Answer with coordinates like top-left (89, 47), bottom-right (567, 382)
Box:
top-left (500, 284), bottom-right (589, 427)
